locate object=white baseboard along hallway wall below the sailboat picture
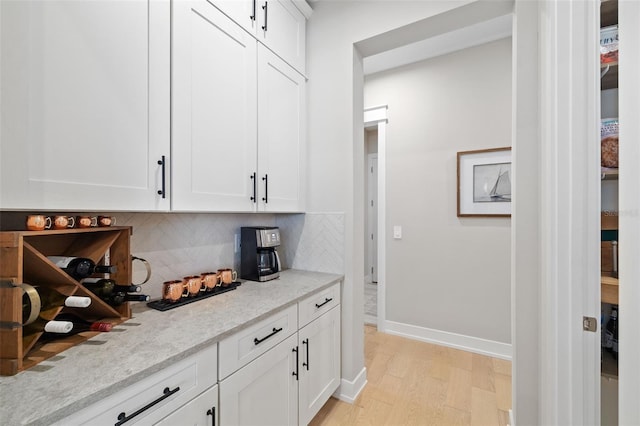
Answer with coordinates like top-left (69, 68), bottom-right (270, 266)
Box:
top-left (384, 321), bottom-right (512, 361)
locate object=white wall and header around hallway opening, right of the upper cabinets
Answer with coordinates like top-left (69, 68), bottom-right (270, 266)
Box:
top-left (306, 0), bottom-right (516, 400)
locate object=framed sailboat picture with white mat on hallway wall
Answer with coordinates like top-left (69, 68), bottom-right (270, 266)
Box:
top-left (458, 148), bottom-right (511, 217)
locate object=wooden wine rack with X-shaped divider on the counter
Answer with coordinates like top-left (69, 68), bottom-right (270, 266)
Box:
top-left (0, 226), bottom-right (132, 376)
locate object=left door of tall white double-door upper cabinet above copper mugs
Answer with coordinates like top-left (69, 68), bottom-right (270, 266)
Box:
top-left (171, 0), bottom-right (257, 211)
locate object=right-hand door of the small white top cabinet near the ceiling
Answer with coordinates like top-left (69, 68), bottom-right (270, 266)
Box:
top-left (256, 0), bottom-right (306, 74)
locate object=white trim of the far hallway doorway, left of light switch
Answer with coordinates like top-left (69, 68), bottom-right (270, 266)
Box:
top-left (364, 105), bottom-right (388, 332)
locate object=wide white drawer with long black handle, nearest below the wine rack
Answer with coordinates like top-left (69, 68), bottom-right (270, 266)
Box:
top-left (56, 344), bottom-right (218, 426)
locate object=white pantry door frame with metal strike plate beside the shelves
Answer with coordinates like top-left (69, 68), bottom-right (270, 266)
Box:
top-left (536, 0), bottom-right (601, 425)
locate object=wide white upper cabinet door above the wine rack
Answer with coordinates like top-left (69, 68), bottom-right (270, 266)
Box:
top-left (0, 0), bottom-right (170, 210)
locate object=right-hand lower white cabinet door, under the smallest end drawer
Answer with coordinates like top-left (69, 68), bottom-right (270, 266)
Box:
top-left (299, 306), bottom-right (340, 425)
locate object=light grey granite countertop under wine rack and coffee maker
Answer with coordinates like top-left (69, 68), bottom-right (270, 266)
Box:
top-left (0, 270), bottom-right (343, 426)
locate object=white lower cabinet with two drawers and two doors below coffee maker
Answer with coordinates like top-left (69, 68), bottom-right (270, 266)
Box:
top-left (219, 284), bottom-right (340, 426)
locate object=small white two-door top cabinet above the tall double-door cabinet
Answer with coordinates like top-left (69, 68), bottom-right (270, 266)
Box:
top-left (213, 0), bottom-right (311, 74)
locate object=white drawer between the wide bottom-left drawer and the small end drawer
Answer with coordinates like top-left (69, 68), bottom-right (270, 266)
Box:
top-left (218, 305), bottom-right (298, 380)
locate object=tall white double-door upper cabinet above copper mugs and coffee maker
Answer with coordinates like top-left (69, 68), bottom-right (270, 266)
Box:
top-left (171, 0), bottom-right (306, 212)
